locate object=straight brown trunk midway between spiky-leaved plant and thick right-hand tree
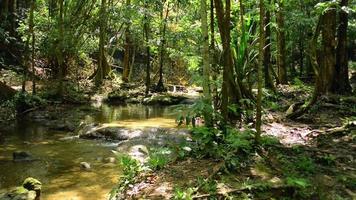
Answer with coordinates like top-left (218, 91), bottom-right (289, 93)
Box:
top-left (277, 0), bottom-right (288, 84)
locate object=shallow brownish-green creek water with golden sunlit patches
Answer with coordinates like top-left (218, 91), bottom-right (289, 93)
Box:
top-left (0, 105), bottom-right (184, 200)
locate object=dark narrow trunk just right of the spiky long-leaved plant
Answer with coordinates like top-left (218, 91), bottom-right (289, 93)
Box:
top-left (263, 1), bottom-right (274, 89)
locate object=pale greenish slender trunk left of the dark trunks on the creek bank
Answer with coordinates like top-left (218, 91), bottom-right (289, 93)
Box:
top-left (200, 0), bottom-right (212, 126)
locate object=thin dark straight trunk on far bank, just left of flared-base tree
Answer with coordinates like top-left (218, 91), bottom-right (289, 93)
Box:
top-left (143, 0), bottom-right (151, 96)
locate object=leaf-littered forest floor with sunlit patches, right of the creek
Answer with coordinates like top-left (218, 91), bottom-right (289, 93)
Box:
top-left (121, 86), bottom-right (356, 199)
